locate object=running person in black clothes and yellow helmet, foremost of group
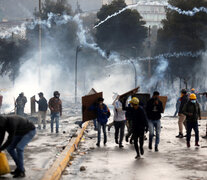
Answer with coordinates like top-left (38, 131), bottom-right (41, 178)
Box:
top-left (122, 97), bottom-right (148, 159)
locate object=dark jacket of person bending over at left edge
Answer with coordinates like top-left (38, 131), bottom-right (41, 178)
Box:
top-left (0, 116), bottom-right (35, 151)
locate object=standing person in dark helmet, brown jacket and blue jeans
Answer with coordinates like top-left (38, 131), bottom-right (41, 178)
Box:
top-left (49, 91), bottom-right (62, 133)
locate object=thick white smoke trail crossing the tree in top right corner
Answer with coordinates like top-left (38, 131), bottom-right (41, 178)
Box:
top-left (167, 4), bottom-right (207, 16)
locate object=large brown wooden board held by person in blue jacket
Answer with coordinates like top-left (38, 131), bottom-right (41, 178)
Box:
top-left (82, 92), bottom-right (103, 122)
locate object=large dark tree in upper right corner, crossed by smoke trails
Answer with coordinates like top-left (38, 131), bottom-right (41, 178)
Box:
top-left (155, 0), bottom-right (207, 86)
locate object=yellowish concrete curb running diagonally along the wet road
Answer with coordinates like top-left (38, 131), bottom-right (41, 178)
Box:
top-left (41, 121), bottom-right (89, 180)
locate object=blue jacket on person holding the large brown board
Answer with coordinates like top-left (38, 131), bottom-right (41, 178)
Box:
top-left (89, 104), bottom-right (108, 125)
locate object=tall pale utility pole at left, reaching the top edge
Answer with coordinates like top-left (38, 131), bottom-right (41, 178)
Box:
top-left (38, 0), bottom-right (42, 85)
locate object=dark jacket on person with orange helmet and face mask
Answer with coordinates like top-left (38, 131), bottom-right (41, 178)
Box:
top-left (182, 101), bottom-right (201, 122)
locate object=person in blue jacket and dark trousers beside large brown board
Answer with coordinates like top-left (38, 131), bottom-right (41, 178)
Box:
top-left (89, 98), bottom-right (110, 147)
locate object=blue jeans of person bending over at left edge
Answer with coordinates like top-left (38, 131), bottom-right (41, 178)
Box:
top-left (7, 129), bottom-right (36, 172)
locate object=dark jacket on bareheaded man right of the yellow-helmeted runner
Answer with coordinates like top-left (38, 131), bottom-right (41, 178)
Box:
top-left (146, 98), bottom-right (163, 120)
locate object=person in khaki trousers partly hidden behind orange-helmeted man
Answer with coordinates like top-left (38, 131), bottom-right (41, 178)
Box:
top-left (176, 89), bottom-right (188, 138)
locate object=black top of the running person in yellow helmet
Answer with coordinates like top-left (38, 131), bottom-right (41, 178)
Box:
top-left (123, 103), bottom-right (148, 135)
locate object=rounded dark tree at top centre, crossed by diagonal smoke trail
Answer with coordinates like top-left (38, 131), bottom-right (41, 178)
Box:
top-left (95, 0), bottom-right (147, 55)
